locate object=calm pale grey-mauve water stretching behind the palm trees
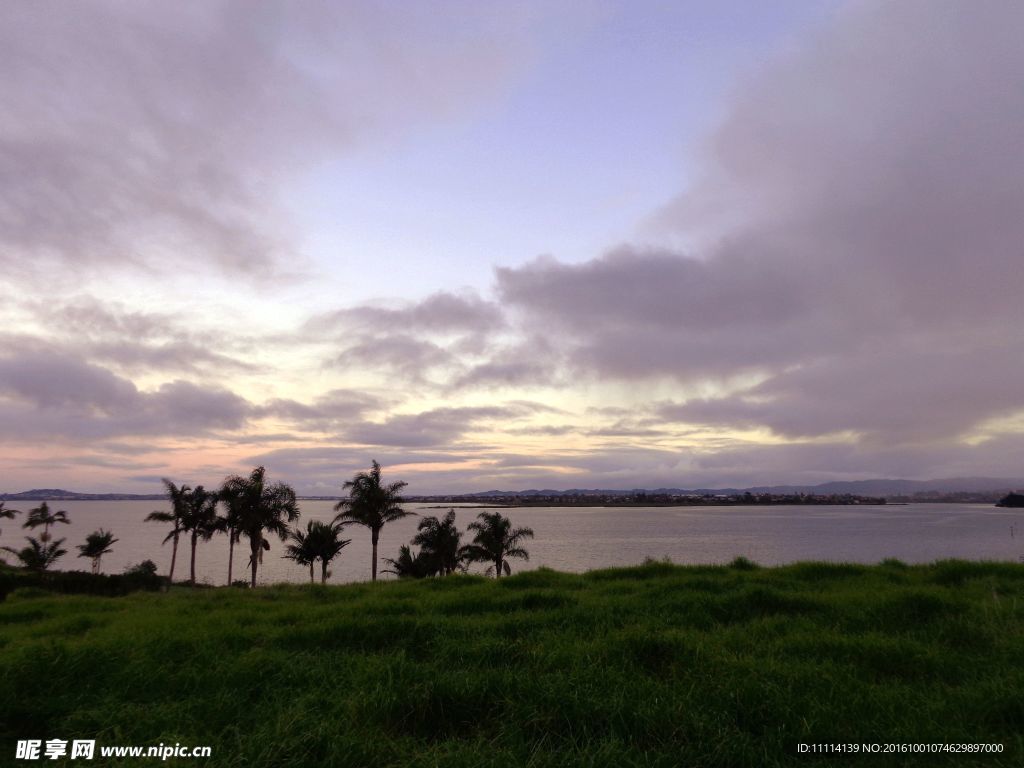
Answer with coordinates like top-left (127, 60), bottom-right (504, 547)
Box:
top-left (0, 502), bottom-right (1024, 584)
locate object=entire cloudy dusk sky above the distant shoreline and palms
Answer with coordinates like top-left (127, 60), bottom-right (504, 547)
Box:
top-left (0, 0), bottom-right (1024, 495)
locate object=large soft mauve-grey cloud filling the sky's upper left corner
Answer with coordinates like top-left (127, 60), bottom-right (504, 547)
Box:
top-left (0, 0), bottom-right (531, 278)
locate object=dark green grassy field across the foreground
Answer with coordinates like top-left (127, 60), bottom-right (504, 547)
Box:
top-left (0, 561), bottom-right (1024, 768)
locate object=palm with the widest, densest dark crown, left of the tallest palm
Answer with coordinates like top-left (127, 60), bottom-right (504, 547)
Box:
top-left (216, 467), bottom-right (299, 589)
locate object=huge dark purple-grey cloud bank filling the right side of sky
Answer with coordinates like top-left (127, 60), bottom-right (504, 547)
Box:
top-left (497, 1), bottom-right (1024, 445)
